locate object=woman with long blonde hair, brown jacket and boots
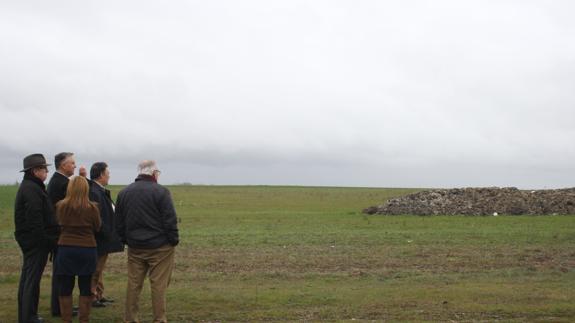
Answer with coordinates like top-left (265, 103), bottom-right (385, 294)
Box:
top-left (55, 176), bottom-right (101, 323)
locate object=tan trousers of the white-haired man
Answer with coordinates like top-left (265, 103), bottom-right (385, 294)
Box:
top-left (124, 245), bottom-right (175, 323)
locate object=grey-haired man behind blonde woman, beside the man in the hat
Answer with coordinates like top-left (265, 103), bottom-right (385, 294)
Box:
top-left (48, 152), bottom-right (86, 316)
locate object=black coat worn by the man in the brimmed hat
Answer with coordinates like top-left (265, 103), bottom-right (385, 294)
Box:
top-left (14, 175), bottom-right (60, 252)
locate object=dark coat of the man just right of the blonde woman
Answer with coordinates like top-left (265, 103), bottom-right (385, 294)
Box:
top-left (90, 181), bottom-right (124, 256)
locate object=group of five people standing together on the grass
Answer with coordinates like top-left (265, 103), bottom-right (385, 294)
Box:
top-left (14, 152), bottom-right (179, 323)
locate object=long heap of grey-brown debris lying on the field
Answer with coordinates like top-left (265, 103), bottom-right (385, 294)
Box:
top-left (363, 187), bottom-right (575, 215)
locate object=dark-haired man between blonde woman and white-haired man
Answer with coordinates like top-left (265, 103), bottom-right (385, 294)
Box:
top-left (90, 162), bottom-right (124, 307)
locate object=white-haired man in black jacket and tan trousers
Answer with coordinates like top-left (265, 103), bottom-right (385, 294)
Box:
top-left (116, 160), bottom-right (179, 322)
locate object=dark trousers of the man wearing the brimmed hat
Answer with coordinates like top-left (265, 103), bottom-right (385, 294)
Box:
top-left (18, 248), bottom-right (49, 323)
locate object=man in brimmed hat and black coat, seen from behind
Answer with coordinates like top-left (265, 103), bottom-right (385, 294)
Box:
top-left (14, 154), bottom-right (59, 323)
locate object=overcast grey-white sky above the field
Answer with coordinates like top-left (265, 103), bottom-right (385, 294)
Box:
top-left (0, 0), bottom-right (575, 188)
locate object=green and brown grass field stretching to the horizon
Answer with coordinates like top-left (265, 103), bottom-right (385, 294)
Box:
top-left (0, 186), bottom-right (575, 322)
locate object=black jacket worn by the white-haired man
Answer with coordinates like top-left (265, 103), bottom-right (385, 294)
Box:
top-left (116, 175), bottom-right (179, 249)
